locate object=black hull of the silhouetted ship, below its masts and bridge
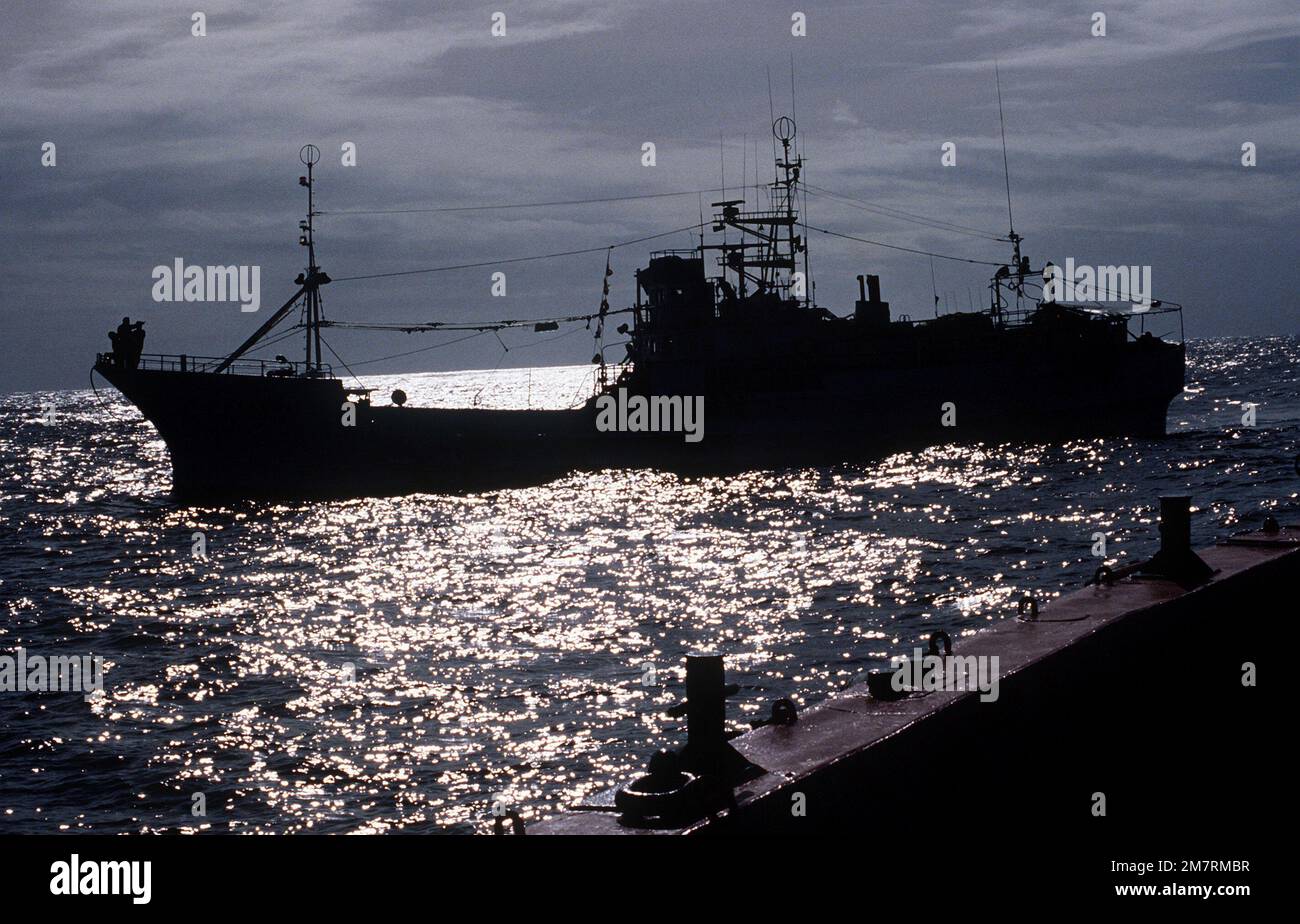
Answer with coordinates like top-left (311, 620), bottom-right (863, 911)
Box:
top-left (96, 332), bottom-right (1183, 502)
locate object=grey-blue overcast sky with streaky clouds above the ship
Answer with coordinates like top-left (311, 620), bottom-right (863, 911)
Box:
top-left (0, 0), bottom-right (1300, 392)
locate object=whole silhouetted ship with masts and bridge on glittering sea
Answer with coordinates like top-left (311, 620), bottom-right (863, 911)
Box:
top-left (95, 117), bottom-right (1184, 502)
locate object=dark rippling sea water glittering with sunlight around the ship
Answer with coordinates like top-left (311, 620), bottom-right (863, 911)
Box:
top-left (0, 338), bottom-right (1300, 833)
